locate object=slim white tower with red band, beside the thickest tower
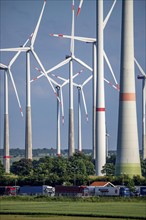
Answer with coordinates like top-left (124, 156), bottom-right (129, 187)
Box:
top-left (95, 0), bottom-right (106, 176)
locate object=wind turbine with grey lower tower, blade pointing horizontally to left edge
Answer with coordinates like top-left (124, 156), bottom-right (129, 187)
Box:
top-left (0, 0), bottom-right (55, 159)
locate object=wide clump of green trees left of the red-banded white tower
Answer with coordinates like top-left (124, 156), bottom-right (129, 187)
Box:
top-left (6, 153), bottom-right (95, 186)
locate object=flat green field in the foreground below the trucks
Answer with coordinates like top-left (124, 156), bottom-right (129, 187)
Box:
top-left (0, 198), bottom-right (146, 220)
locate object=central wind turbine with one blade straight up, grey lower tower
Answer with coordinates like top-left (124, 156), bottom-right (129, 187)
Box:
top-left (34, 0), bottom-right (92, 157)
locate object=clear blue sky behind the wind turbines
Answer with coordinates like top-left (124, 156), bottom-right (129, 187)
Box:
top-left (0, 0), bottom-right (146, 149)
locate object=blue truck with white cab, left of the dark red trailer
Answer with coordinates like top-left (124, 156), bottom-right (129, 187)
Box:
top-left (18, 185), bottom-right (55, 196)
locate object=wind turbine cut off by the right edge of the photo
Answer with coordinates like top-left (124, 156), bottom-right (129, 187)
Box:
top-left (134, 58), bottom-right (146, 160)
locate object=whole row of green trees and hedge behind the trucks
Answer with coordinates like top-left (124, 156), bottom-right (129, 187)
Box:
top-left (0, 153), bottom-right (146, 188)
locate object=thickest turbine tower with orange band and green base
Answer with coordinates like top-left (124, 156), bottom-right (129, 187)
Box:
top-left (115, 0), bottom-right (141, 177)
